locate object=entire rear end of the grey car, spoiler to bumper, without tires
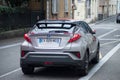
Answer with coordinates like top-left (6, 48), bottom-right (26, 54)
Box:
top-left (21, 23), bottom-right (85, 67)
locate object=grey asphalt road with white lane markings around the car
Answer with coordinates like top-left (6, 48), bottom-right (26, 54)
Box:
top-left (0, 17), bottom-right (120, 80)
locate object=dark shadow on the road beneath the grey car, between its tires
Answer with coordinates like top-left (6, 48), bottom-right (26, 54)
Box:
top-left (34, 67), bottom-right (79, 78)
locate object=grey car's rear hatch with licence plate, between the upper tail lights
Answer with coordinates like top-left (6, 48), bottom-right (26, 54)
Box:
top-left (30, 25), bottom-right (73, 49)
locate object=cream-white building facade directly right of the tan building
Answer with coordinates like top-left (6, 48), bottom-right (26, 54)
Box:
top-left (74, 0), bottom-right (99, 22)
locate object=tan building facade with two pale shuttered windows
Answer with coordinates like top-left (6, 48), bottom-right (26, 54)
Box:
top-left (47, 0), bottom-right (72, 19)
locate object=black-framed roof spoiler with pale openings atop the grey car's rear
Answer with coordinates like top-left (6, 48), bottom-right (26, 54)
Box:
top-left (36, 23), bottom-right (75, 29)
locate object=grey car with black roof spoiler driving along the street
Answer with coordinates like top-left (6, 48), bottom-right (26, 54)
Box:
top-left (20, 20), bottom-right (100, 75)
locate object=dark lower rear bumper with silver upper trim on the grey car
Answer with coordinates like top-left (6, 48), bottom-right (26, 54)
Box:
top-left (21, 52), bottom-right (83, 67)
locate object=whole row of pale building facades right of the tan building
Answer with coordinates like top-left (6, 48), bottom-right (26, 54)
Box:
top-left (72, 0), bottom-right (116, 22)
